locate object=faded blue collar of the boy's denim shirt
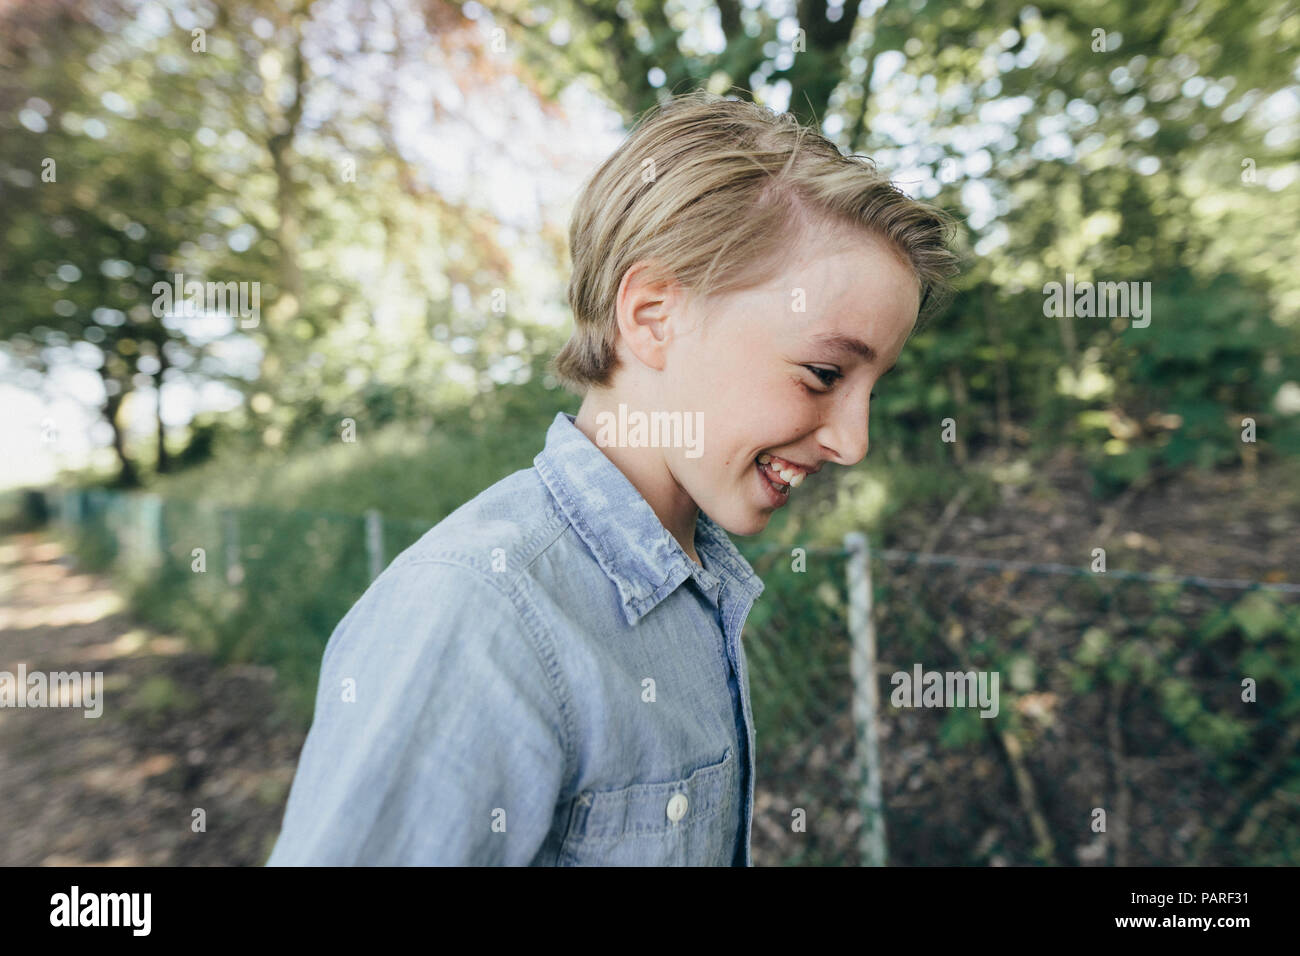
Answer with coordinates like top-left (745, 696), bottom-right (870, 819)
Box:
top-left (533, 411), bottom-right (764, 624)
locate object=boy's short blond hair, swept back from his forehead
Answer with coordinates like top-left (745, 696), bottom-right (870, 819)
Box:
top-left (551, 90), bottom-right (958, 394)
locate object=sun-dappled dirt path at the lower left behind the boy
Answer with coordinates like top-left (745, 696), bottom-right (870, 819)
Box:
top-left (0, 535), bottom-right (303, 866)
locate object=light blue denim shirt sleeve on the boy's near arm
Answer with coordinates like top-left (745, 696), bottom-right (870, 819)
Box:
top-left (267, 561), bottom-right (566, 866)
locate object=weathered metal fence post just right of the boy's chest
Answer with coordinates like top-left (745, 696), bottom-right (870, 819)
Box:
top-left (844, 531), bottom-right (885, 866)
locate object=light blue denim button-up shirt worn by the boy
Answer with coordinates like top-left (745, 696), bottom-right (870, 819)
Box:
top-left (267, 412), bottom-right (763, 866)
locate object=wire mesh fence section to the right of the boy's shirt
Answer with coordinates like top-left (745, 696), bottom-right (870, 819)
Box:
top-left (746, 541), bottom-right (1300, 865)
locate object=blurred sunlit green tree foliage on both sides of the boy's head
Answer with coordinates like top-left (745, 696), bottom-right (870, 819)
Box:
top-left (0, 0), bottom-right (1300, 509)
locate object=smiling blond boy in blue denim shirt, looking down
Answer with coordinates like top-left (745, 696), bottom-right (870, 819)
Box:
top-left (268, 92), bottom-right (956, 866)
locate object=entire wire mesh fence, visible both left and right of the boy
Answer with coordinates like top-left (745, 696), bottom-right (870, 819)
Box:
top-left (27, 490), bottom-right (1300, 865)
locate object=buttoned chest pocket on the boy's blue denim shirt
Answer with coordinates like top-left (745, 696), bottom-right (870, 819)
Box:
top-left (558, 747), bottom-right (740, 866)
